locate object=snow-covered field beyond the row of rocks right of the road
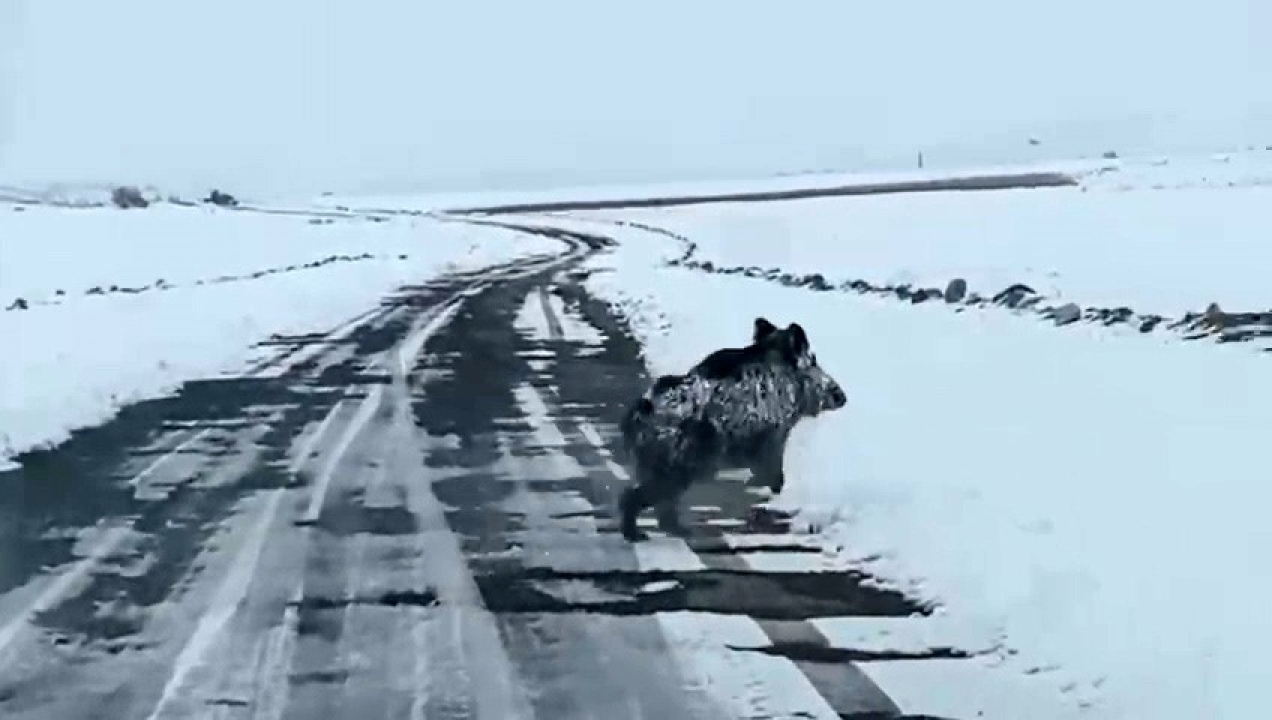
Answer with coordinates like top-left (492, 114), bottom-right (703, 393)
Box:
top-left (583, 151), bottom-right (1272, 317)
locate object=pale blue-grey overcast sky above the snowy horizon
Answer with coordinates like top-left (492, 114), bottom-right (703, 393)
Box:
top-left (0, 0), bottom-right (1272, 192)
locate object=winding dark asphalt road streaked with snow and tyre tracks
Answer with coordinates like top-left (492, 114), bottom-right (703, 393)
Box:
top-left (0, 220), bottom-right (959, 720)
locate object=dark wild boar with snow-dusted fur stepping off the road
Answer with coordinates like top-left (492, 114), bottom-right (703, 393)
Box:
top-left (619, 318), bottom-right (847, 541)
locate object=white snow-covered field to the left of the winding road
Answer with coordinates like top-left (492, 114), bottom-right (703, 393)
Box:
top-left (0, 205), bottom-right (561, 462)
